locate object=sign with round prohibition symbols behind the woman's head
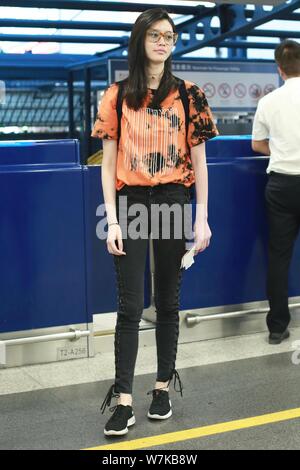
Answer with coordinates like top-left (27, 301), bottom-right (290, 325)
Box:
top-left (109, 59), bottom-right (280, 112)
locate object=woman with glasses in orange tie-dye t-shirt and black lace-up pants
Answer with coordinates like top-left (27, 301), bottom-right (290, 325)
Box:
top-left (92, 8), bottom-right (218, 436)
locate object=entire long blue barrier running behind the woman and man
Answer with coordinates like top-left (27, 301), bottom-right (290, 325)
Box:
top-left (0, 136), bottom-right (300, 333)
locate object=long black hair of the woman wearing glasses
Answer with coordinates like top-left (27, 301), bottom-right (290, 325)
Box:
top-left (124, 8), bottom-right (178, 111)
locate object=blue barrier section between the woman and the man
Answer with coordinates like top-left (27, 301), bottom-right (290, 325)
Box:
top-left (180, 136), bottom-right (300, 309)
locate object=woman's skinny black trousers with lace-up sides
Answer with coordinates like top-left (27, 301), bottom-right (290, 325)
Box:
top-left (114, 183), bottom-right (191, 394)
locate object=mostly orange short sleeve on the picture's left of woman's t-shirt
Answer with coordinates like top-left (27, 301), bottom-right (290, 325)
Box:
top-left (91, 84), bottom-right (118, 140)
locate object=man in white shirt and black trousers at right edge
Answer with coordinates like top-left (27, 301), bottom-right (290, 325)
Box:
top-left (252, 40), bottom-right (300, 344)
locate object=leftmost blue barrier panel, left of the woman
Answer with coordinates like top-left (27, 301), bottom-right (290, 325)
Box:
top-left (0, 140), bottom-right (88, 333)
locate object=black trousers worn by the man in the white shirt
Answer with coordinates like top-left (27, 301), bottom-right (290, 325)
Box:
top-left (265, 172), bottom-right (300, 333)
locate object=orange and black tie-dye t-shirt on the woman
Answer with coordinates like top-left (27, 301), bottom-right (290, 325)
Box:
top-left (92, 81), bottom-right (218, 190)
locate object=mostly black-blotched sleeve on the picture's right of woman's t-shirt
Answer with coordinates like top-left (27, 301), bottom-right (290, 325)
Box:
top-left (186, 82), bottom-right (219, 147)
